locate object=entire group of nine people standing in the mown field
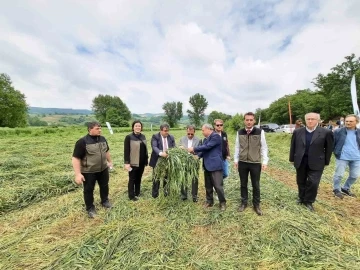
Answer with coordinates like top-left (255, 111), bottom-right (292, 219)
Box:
top-left (72, 112), bottom-right (360, 218)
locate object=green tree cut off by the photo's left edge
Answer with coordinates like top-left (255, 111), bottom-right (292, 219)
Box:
top-left (0, 73), bottom-right (28, 127)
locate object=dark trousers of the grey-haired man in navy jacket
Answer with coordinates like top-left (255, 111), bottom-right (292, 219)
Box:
top-left (204, 170), bottom-right (226, 204)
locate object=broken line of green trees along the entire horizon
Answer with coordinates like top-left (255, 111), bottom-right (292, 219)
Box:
top-left (0, 54), bottom-right (360, 130)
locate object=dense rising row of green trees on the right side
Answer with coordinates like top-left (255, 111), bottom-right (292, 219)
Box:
top-left (256, 54), bottom-right (360, 124)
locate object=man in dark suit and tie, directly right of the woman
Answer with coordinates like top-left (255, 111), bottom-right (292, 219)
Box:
top-left (149, 124), bottom-right (175, 198)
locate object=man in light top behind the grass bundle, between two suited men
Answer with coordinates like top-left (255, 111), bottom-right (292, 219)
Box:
top-left (179, 125), bottom-right (201, 202)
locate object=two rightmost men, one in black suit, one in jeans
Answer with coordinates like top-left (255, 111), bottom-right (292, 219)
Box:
top-left (289, 113), bottom-right (360, 211)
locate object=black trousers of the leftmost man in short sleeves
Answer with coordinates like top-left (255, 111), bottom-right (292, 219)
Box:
top-left (82, 168), bottom-right (109, 211)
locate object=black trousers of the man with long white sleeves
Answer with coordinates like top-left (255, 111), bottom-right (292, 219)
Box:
top-left (238, 161), bottom-right (261, 206)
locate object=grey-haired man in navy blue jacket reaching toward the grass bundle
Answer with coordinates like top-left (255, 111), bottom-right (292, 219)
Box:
top-left (188, 124), bottom-right (226, 211)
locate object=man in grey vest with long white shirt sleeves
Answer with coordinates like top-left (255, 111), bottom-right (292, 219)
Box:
top-left (234, 112), bottom-right (269, 216)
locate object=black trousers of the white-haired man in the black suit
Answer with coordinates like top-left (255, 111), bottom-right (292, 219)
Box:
top-left (296, 156), bottom-right (324, 203)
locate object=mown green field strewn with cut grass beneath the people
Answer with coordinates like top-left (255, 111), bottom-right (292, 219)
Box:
top-left (0, 128), bottom-right (360, 270)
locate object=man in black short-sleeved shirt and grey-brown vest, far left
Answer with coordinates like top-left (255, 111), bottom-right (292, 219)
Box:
top-left (72, 122), bottom-right (112, 218)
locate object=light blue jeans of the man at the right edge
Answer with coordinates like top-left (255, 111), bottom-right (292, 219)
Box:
top-left (334, 159), bottom-right (360, 190)
